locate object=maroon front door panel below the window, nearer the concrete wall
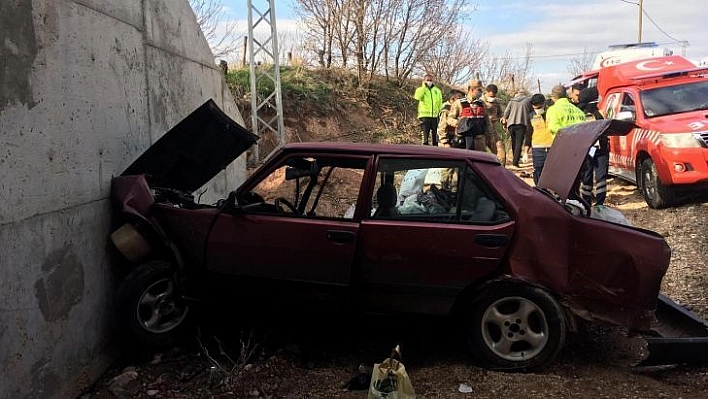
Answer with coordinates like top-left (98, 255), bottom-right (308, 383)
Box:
top-left (207, 212), bottom-right (358, 285)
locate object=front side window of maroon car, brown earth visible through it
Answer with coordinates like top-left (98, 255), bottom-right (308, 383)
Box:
top-left (244, 156), bottom-right (367, 219)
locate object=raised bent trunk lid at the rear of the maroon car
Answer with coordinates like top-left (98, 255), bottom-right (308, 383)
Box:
top-left (538, 119), bottom-right (636, 202)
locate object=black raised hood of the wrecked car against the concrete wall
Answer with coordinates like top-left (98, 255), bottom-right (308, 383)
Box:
top-left (121, 100), bottom-right (258, 193)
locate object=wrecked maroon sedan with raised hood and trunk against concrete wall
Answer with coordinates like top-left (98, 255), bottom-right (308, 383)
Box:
top-left (113, 103), bottom-right (670, 369)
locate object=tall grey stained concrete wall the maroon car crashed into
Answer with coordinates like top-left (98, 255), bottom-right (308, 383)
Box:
top-left (0, 0), bottom-right (245, 398)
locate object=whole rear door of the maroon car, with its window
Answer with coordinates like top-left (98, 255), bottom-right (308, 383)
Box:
top-left (354, 157), bottom-right (514, 313)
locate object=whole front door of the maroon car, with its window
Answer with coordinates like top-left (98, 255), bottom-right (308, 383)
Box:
top-left (208, 154), bottom-right (369, 285)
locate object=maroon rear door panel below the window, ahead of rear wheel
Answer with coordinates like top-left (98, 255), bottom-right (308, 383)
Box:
top-left (354, 220), bottom-right (514, 313)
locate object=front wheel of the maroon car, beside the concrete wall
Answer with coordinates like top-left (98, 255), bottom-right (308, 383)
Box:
top-left (118, 261), bottom-right (190, 347)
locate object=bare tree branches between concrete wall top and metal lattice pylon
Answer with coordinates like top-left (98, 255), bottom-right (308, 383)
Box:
top-left (189, 0), bottom-right (239, 58)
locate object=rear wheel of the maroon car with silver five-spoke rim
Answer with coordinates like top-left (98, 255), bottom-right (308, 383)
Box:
top-left (467, 284), bottom-right (566, 370)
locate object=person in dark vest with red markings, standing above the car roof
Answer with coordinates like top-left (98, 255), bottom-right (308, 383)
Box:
top-left (447, 79), bottom-right (492, 151)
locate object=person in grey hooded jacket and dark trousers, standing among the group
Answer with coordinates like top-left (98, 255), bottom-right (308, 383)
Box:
top-left (502, 89), bottom-right (532, 168)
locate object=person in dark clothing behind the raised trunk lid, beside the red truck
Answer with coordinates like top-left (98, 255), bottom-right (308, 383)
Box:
top-left (578, 87), bottom-right (610, 205)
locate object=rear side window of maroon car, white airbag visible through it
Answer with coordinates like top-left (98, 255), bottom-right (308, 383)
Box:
top-left (370, 159), bottom-right (509, 224)
